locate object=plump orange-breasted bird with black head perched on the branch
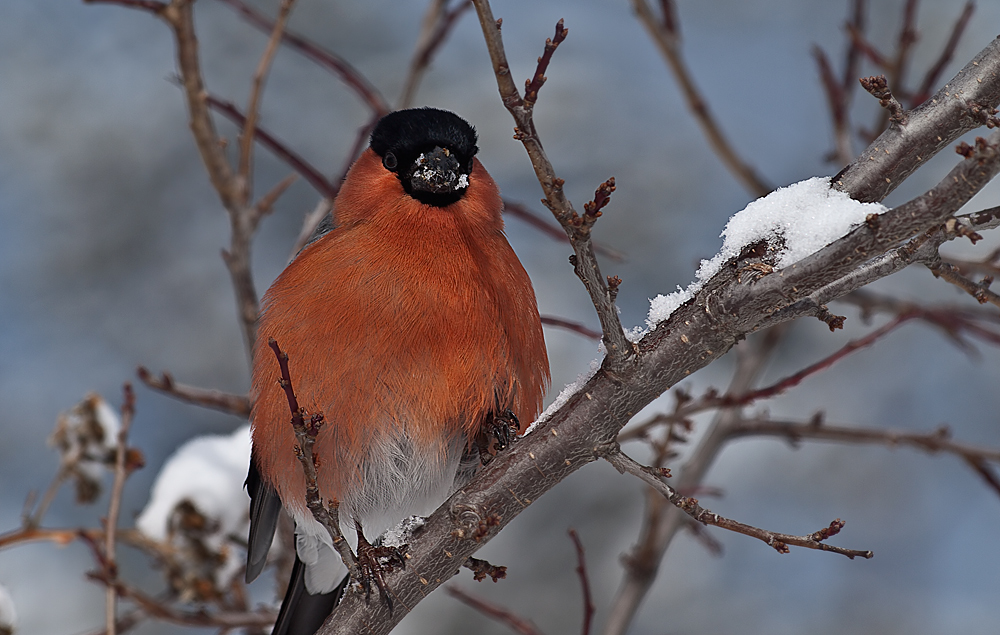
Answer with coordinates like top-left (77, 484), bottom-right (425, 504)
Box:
top-left (246, 108), bottom-right (550, 635)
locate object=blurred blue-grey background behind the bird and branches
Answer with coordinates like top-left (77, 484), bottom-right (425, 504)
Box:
top-left (0, 0), bottom-right (1000, 635)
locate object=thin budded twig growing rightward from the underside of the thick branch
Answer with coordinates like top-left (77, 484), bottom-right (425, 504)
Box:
top-left (603, 444), bottom-right (874, 560)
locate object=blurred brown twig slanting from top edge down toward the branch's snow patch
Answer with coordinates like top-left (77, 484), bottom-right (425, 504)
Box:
top-left (632, 0), bottom-right (774, 196)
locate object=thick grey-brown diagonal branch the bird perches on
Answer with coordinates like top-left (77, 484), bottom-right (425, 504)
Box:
top-left (320, 22), bottom-right (1000, 635)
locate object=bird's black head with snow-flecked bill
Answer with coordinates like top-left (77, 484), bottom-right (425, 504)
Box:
top-left (371, 108), bottom-right (479, 207)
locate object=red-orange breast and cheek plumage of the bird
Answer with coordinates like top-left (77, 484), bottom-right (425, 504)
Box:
top-left (251, 149), bottom-right (548, 513)
